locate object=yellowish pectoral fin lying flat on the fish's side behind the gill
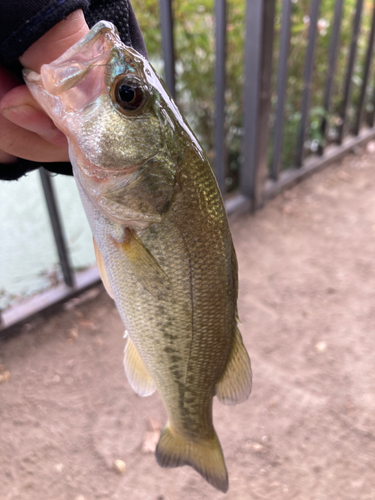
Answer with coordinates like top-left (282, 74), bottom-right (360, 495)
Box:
top-left (121, 230), bottom-right (171, 298)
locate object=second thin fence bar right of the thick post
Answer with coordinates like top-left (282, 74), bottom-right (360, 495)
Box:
top-left (296, 0), bottom-right (320, 167)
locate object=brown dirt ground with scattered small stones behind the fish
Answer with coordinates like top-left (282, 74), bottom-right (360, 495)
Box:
top-left (0, 145), bottom-right (375, 500)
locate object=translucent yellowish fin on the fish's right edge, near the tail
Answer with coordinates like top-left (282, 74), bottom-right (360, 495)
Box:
top-left (216, 326), bottom-right (252, 405)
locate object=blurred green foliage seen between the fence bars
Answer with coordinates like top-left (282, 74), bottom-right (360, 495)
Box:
top-left (132, 0), bottom-right (375, 189)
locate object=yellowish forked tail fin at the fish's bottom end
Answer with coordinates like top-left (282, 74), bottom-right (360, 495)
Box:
top-left (155, 423), bottom-right (228, 493)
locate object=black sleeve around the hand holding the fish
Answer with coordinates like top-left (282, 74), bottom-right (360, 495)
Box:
top-left (0, 0), bottom-right (147, 180)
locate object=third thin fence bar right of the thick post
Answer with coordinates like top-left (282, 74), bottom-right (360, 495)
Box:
top-left (318, 0), bottom-right (343, 155)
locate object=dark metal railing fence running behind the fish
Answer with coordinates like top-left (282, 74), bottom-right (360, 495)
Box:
top-left (3, 0), bottom-right (375, 328)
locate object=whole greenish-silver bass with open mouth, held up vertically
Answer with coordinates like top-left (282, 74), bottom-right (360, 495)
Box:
top-left (24, 21), bottom-right (252, 492)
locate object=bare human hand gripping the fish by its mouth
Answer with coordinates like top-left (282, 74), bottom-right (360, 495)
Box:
top-left (0, 10), bottom-right (89, 163)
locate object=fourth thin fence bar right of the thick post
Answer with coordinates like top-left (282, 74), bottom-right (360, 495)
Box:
top-left (337, 0), bottom-right (363, 144)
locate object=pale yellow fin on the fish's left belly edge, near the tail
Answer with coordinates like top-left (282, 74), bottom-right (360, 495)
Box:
top-left (124, 337), bottom-right (156, 396)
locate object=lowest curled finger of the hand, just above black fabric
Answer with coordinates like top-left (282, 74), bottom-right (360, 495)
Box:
top-left (0, 115), bottom-right (69, 163)
